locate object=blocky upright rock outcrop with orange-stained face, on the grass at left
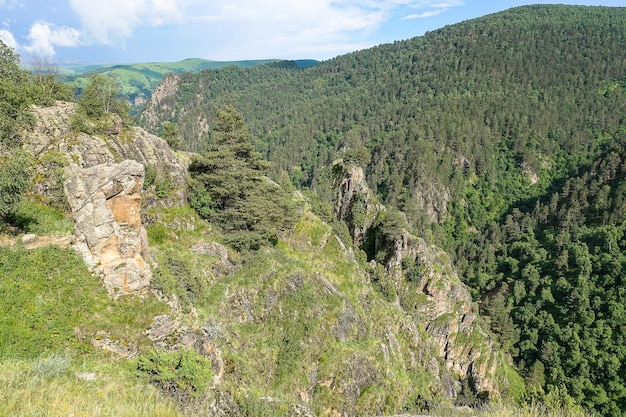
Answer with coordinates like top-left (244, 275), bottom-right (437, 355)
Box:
top-left (65, 160), bottom-right (152, 296)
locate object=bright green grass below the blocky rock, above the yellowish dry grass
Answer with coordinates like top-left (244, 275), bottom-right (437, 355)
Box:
top-left (0, 246), bottom-right (169, 359)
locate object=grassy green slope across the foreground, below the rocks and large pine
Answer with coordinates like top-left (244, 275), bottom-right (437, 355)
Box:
top-left (0, 197), bottom-right (588, 416)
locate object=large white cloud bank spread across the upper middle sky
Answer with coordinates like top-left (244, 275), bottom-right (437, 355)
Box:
top-left (63, 0), bottom-right (463, 59)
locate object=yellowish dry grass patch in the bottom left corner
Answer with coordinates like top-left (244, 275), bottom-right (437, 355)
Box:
top-left (0, 355), bottom-right (184, 417)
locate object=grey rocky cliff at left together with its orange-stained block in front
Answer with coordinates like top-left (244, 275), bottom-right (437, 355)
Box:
top-left (24, 102), bottom-right (187, 296)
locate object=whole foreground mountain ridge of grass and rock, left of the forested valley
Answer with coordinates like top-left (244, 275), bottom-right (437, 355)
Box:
top-left (0, 101), bottom-right (520, 416)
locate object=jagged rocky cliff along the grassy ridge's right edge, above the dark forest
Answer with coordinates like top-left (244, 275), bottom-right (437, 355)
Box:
top-left (334, 162), bottom-right (501, 397)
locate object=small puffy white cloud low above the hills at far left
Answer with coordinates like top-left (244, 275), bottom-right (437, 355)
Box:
top-left (24, 22), bottom-right (80, 57)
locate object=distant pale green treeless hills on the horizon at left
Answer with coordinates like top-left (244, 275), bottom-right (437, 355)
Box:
top-left (59, 58), bottom-right (317, 110)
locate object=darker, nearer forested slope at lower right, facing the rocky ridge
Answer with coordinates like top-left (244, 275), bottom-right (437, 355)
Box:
top-left (466, 134), bottom-right (626, 415)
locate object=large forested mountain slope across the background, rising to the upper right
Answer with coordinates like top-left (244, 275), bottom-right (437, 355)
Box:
top-left (141, 6), bottom-right (626, 231)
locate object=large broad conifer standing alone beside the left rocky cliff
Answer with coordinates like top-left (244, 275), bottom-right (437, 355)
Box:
top-left (189, 106), bottom-right (295, 249)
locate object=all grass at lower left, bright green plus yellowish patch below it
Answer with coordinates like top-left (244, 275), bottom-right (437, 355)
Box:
top-left (0, 242), bottom-right (182, 417)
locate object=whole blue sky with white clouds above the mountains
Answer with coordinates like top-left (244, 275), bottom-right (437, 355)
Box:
top-left (0, 0), bottom-right (626, 65)
